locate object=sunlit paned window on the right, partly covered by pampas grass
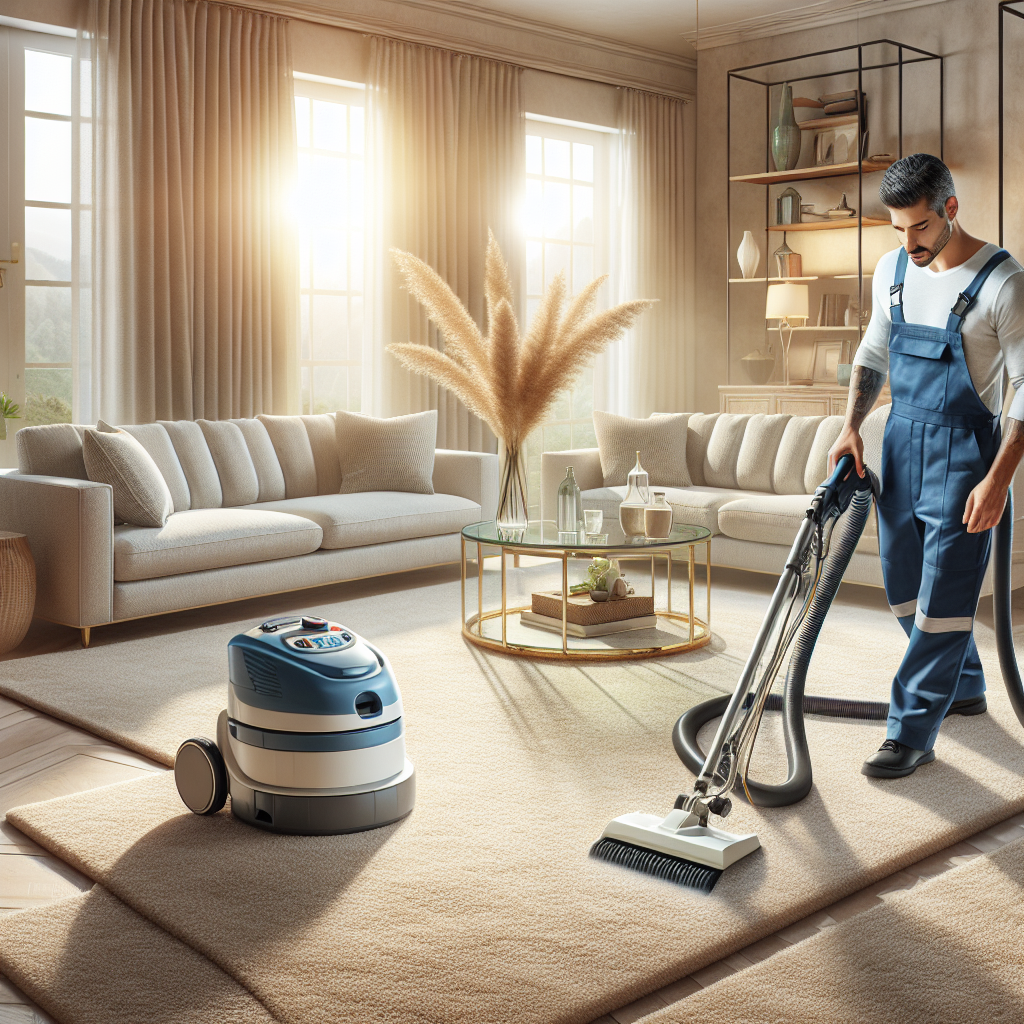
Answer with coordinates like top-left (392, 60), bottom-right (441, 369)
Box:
top-left (524, 115), bottom-right (610, 518)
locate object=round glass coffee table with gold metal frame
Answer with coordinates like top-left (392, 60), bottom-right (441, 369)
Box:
top-left (462, 520), bottom-right (712, 660)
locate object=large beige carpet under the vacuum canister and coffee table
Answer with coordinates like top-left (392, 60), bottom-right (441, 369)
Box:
top-left (0, 570), bottom-right (1024, 1024)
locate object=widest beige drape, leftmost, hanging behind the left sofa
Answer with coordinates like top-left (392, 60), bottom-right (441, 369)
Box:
top-left (88, 0), bottom-right (298, 423)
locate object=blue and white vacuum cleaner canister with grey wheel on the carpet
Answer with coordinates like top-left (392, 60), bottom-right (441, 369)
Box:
top-left (174, 615), bottom-right (416, 836)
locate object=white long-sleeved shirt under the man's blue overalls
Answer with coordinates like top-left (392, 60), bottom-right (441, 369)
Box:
top-left (853, 242), bottom-right (1024, 420)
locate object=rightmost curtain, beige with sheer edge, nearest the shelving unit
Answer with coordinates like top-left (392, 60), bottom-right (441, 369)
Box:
top-left (595, 89), bottom-right (691, 416)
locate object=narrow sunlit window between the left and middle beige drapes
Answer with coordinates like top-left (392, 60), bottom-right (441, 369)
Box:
top-left (295, 76), bottom-right (366, 413)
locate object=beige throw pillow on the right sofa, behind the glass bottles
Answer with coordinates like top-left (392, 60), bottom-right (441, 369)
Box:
top-left (594, 412), bottom-right (690, 487)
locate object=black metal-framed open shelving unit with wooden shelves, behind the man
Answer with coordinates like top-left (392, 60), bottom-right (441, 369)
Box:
top-left (726, 39), bottom-right (944, 388)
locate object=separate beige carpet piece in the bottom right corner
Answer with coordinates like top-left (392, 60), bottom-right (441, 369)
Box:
top-left (644, 840), bottom-right (1024, 1024)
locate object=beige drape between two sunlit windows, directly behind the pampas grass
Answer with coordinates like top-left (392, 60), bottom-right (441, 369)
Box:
top-left (367, 37), bottom-right (525, 452)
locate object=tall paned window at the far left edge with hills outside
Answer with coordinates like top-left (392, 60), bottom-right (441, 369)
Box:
top-left (0, 29), bottom-right (91, 440)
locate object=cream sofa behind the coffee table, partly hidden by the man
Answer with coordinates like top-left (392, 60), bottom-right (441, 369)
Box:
top-left (541, 406), bottom-right (1024, 594)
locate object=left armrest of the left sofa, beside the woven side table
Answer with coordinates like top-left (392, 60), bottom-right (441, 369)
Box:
top-left (0, 473), bottom-right (114, 628)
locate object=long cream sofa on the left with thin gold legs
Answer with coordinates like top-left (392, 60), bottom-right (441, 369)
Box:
top-left (0, 415), bottom-right (498, 643)
